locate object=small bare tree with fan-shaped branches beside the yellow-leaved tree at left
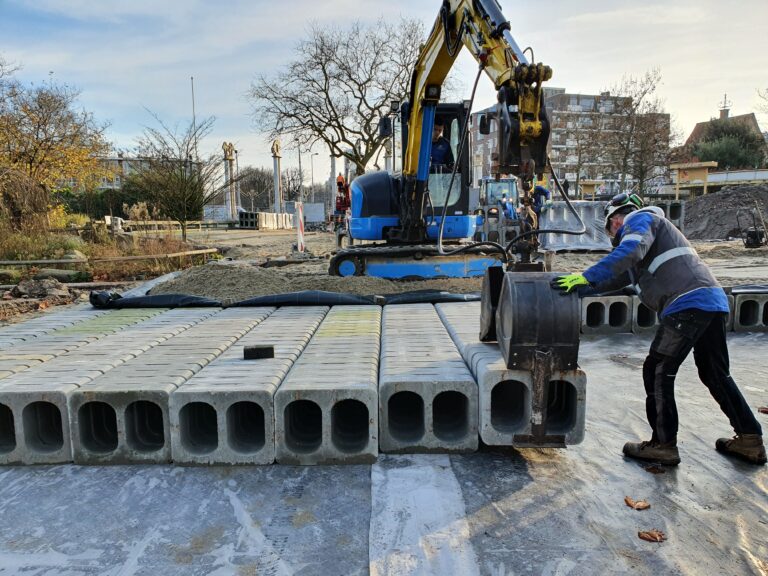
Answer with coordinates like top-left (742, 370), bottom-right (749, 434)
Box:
top-left (129, 114), bottom-right (237, 241)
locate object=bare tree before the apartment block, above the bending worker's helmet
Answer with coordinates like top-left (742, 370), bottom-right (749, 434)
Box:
top-left (603, 69), bottom-right (670, 193)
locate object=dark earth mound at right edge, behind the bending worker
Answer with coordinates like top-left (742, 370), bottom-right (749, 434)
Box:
top-left (684, 185), bottom-right (768, 240)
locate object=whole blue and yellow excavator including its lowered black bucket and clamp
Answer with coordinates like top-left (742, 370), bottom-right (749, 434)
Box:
top-left (330, 0), bottom-right (585, 446)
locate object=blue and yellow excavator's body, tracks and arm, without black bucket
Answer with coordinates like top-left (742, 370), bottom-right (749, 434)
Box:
top-left (329, 0), bottom-right (576, 278)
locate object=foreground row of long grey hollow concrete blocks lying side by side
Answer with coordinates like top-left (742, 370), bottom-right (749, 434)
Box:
top-left (0, 303), bottom-right (585, 464)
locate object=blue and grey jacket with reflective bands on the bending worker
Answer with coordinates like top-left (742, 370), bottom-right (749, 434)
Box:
top-left (584, 206), bottom-right (729, 316)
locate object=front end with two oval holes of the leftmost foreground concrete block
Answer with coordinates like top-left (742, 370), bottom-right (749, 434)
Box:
top-left (0, 384), bottom-right (76, 464)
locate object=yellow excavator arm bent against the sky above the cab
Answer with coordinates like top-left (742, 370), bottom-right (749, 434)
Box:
top-left (403, 0), bottom-right (552, 180)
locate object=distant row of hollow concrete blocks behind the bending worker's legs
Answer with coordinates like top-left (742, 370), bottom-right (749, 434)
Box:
top-left (581, 293), bottom-right (768, 334)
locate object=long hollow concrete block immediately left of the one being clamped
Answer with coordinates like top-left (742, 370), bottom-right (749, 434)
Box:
top-left (379, 304), bottom-right (478, 452)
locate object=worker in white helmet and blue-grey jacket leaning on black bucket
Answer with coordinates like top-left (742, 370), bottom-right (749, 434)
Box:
top-left (552, 194), bottom-right (766, 466)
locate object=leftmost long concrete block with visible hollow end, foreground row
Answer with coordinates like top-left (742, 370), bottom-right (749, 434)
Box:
top-left (0, 310), bottom-right (220, 464)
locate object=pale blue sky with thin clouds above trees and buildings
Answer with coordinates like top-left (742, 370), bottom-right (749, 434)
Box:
top-left (0, 0), bottom-right (768, 181)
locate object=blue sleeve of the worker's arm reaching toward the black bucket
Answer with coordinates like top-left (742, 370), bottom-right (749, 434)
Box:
top-left (584, 212), bottom-right (656, 286)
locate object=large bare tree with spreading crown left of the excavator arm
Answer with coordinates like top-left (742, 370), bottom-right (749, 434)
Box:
top-left (249, 19), bottom-right (424, 174)
